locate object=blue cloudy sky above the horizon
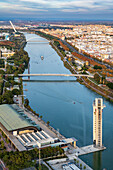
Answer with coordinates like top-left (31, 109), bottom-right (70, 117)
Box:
top-left (0, 0), bottom-right (113, 20)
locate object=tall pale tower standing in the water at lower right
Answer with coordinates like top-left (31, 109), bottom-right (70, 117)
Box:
top-left (93, 98), bottom-right (105, 147)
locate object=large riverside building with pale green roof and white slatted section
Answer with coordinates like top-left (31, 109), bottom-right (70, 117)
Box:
top-left (0, 104), bottom-right (76, 151)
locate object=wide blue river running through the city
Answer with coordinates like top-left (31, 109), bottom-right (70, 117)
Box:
top-left (23, 33), bottom-right (113, 170)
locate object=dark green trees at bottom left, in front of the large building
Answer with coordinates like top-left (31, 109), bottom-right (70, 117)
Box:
top-left (0, 146), bottom-right (64, 170)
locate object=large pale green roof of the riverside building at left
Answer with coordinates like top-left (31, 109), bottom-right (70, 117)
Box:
top-left (0, 104), bottom-right (33, 131)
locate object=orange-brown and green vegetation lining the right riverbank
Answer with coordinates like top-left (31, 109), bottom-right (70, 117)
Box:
top-left (35, 31), bottom-right (113, 102)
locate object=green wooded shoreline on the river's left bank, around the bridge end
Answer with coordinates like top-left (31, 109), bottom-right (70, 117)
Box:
top-left (0, 33), bottom-right (30, 104)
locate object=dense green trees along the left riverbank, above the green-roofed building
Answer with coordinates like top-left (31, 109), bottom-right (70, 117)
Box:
top-left (0, 34), bottom-right (30, 104)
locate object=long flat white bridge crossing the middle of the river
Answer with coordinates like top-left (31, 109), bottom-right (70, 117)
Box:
top-left (5, 73), bottom-right (94, 78)
